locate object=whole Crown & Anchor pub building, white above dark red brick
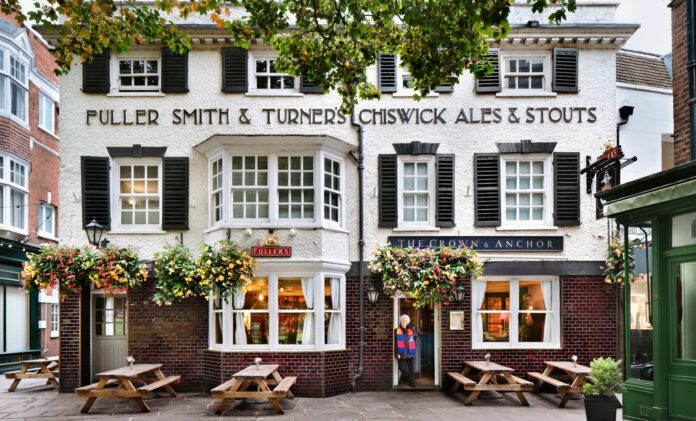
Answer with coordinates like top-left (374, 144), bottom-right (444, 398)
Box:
top-left (47, 1), bottom-right (637, 396)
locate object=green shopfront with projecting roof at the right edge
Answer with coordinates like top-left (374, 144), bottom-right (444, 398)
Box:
top-left (597, 162), bottom-right (696, 420)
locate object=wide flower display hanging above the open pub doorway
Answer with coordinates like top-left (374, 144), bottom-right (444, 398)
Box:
top-left (369, 245), bottom-right (483, 307)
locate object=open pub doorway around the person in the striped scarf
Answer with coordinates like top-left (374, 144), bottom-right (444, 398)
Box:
top-left (393, 297), bottom-right (440, 390)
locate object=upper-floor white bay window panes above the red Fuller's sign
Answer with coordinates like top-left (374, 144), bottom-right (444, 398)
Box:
top-left (209, 151), bottom-right (344, 227)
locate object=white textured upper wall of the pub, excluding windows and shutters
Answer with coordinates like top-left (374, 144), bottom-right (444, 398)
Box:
top-left (60, 1), bottom-right (635, 273)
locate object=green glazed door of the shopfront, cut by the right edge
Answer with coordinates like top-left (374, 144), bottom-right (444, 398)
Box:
top-left (668, 253), bottom-right (696, 420)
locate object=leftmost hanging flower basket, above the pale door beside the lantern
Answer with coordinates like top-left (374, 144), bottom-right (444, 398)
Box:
top-left (83, 245), bottom-right (147, 293)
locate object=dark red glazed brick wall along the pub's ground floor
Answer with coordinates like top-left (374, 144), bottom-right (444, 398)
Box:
top-left (60, 270), bottom-right (619, 397)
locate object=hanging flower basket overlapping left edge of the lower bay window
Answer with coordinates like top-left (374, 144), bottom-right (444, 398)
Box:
top-left (198, 240), bottom-right (255, 300)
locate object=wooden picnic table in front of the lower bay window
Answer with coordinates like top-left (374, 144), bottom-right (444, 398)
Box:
top-left (211, 364), bottom-right (297, 415)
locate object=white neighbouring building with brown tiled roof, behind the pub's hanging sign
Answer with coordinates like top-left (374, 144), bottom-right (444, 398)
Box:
top-left (616, 49), bottom-right (674, 183)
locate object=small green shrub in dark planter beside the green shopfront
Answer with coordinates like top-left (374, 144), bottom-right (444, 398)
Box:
top-left (583, 358), bottom-right (622, 421)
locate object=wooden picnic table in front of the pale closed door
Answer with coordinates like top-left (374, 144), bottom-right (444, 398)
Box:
top-left (75, 364), bottom-right (181, 414)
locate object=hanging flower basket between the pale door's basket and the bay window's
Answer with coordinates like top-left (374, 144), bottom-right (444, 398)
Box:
top-left (153, 244), bottom-right (207, 305)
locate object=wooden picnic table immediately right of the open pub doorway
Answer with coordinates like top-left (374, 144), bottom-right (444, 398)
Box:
top-left (447, 361), bottom-right (533, 406)
